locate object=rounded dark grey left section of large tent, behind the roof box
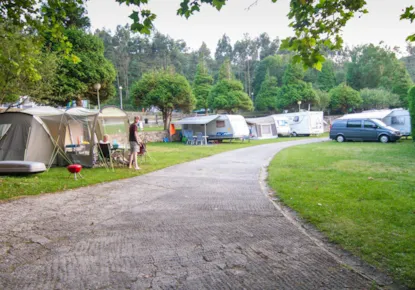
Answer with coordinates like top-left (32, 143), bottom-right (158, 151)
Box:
top-left (0, 112), bottom-right (56, 165)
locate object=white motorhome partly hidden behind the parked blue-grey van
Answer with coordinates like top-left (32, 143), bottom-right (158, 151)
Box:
top-left (340, 109), bottom-right (411, 136)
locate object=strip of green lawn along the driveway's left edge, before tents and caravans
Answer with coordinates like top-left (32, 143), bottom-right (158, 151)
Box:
top-left (0, 138), bottom-right (316, 200)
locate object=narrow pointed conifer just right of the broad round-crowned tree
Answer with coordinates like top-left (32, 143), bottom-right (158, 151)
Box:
top-left (193, 55), bottom-right (213, 115)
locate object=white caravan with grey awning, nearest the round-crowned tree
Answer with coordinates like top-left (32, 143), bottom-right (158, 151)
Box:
top-left (172, 115), bottom-right (249, 140)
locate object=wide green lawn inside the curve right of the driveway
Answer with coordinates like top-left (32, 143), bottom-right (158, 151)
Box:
top-left (268, 140), bottom-right (415, 288)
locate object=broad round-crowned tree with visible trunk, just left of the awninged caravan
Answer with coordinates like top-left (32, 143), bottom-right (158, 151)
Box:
top-left (131, 69), bottom-right (196, 130)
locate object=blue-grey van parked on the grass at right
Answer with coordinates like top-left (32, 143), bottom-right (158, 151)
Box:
top-left (330, 118), bottom-right (401, 143)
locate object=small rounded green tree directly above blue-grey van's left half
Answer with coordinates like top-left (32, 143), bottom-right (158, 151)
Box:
top-left (329, 83), bottom-right (362, 113)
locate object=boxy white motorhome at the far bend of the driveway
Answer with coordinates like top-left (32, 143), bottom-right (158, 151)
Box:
top-left (273, 111), bottom-right (324, 136)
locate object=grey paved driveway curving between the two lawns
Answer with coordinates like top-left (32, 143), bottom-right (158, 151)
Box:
top-left (0, 139), bottom-right (371, 289)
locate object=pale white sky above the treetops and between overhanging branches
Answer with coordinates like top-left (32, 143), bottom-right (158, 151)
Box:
top-left (87, 0), bottom-right (415, 53)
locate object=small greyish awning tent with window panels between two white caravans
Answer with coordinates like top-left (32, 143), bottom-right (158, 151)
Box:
top-left (245, 116), bottom-right (279, 140)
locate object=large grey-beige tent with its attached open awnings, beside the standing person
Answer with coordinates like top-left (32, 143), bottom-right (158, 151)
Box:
top-left (0, 107), bottom-right (128, 167)
